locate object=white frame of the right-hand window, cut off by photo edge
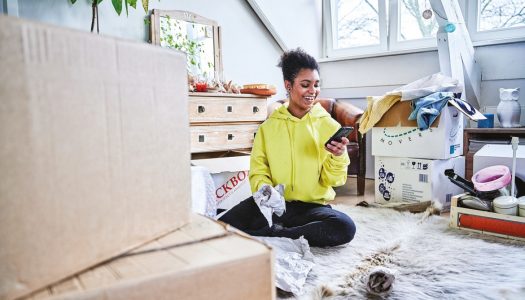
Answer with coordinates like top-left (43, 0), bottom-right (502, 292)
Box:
top-left (465, 0), bottom-right (525, 45)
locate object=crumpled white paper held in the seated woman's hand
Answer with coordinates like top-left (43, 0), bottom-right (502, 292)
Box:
top-left (253, 184), bottom-right (286, 227)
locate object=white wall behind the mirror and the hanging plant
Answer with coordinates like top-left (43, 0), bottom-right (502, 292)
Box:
top-left (14, 0), bottom-right (285, 99)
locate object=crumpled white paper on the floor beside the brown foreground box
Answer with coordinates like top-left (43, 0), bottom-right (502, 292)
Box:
top-left (256, 237), bottom-right (315, 295)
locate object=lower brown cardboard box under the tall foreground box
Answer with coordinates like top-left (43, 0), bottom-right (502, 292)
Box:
top-left (20, 215), bottom-right (275, 300)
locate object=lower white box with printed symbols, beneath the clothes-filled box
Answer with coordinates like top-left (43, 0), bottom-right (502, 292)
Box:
top-left (375, 156), bottom-right (465, 211)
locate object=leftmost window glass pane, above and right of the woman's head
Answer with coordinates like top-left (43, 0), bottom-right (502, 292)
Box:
top-left (334, 0), bottom-right (380, 49)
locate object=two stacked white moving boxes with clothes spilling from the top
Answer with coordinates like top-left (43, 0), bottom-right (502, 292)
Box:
top-left (372, 101), bottom-right (465, 211)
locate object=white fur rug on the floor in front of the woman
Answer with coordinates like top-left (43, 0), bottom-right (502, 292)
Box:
top-left (288, 206), bottom-right (525, 300)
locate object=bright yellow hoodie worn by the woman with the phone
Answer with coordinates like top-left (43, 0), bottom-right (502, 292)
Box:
top-left (250, 104), bottom-right (350, 204)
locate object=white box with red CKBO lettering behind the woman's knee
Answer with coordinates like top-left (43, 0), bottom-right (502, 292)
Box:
top-left (191, 155), bottom-right (252, 209)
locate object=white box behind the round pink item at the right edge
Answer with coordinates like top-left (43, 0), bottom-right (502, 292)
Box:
top-left (469, 144), bottom-right (525, 180)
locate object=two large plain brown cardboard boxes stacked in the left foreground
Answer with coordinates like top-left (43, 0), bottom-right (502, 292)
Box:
top-left (0, 16), bottom-right (274, 299)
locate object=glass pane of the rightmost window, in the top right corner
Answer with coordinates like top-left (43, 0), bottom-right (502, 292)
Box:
top-left (478, 0), bottom-right (525, 31)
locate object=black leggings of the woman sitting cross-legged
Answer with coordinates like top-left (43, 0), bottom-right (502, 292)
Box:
top-left (219, 197), bottom-right (356, 247)
